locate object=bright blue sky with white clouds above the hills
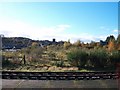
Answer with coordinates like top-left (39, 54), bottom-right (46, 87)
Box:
top-left (0, 2), bottom-right (118, 42)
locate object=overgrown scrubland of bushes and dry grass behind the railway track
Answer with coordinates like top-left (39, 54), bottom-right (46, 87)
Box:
top-left (2, 36), bottom-right (120, 71)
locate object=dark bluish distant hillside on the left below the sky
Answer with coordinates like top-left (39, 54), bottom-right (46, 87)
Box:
top-left (2, 37), bottom-right (64, 49)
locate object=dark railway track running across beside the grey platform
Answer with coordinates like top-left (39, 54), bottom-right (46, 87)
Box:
top-left (1, 71), bottom-right (119, 80)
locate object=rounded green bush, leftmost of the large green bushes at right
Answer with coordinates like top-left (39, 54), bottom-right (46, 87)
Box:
top-left (67, 49), bottom-right (88, 68)
